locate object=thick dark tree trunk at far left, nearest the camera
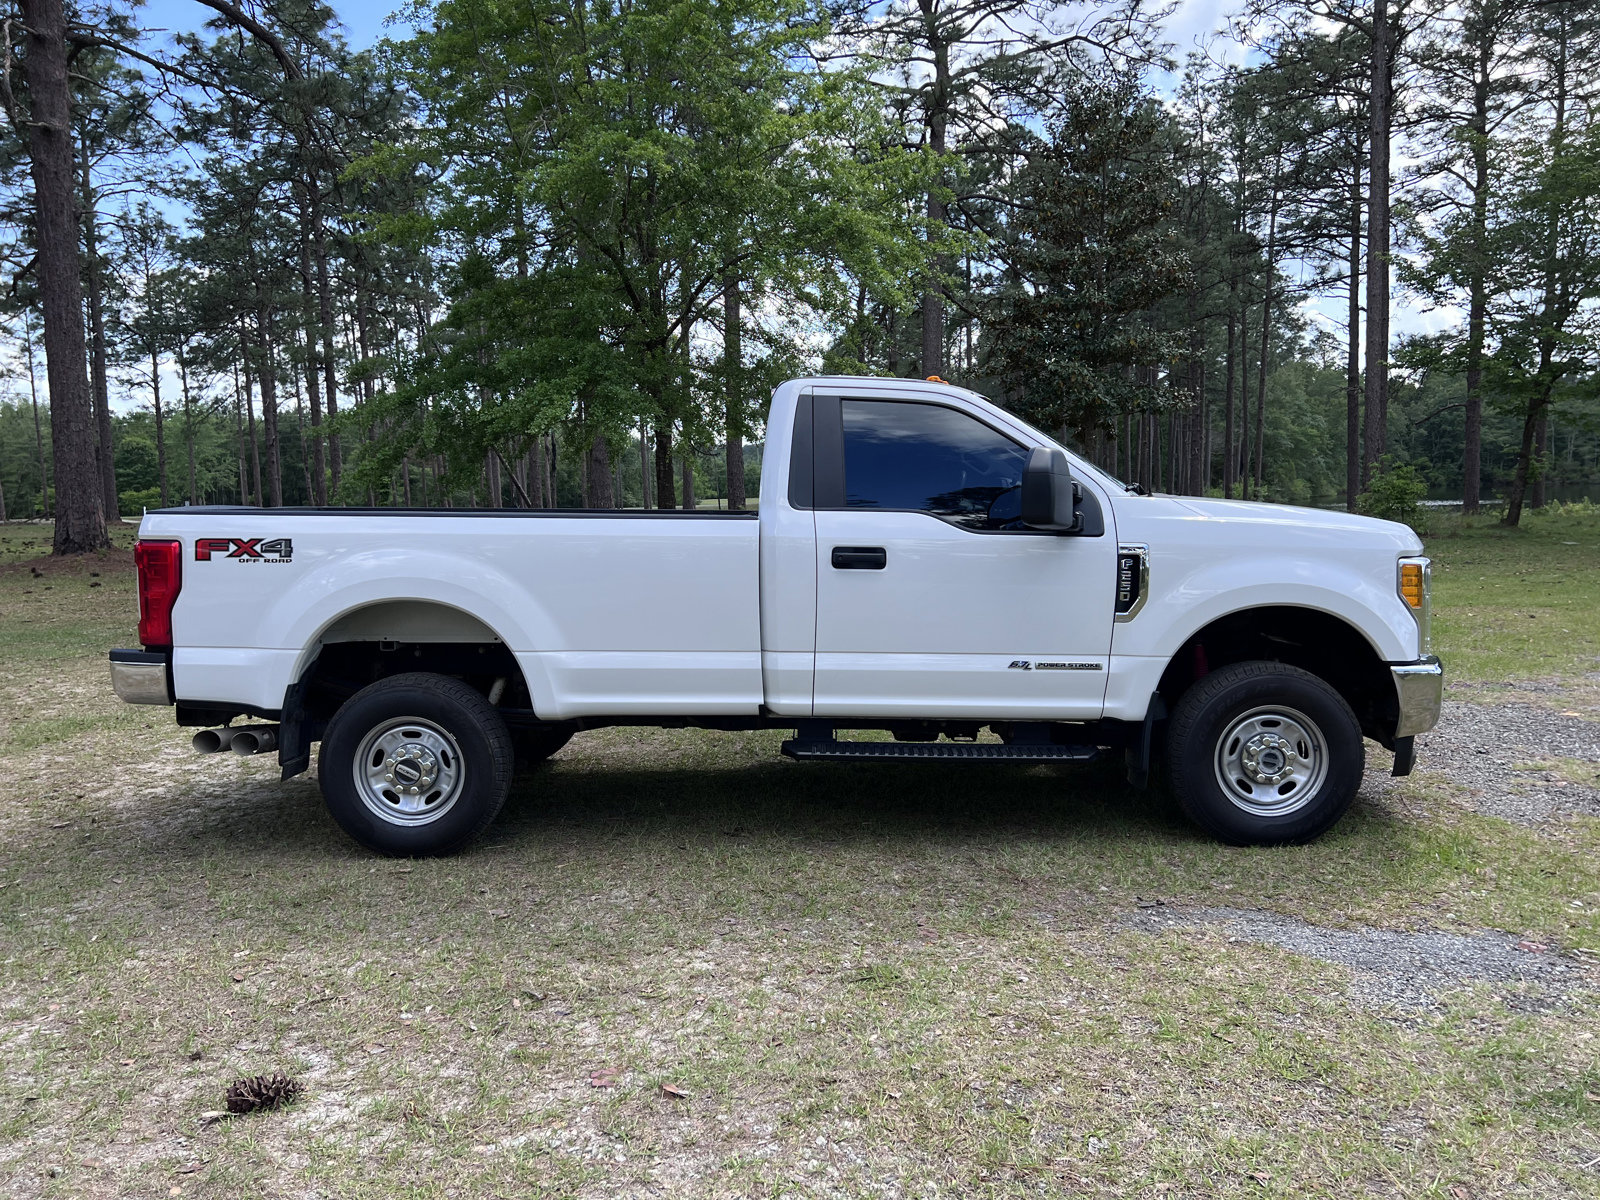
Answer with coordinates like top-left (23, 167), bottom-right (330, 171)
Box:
top-left (21, 0), bottom-right (110, 554)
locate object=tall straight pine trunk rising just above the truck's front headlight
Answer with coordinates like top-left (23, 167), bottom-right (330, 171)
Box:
top-left (1362, 0), bottom-right (1394, 485)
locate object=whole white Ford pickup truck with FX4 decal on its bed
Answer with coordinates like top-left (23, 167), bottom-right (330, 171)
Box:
top-left (110, 378), bottom-right (1443, 854)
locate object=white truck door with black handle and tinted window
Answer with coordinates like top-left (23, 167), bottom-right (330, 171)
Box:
top-left (813, 395), bottom-right (1117, 720)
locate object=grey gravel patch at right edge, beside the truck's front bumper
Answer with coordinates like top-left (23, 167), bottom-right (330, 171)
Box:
top-left (1418, 694), bottom-right (1600, 826)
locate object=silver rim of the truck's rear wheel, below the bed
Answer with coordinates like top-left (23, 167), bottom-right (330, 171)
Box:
top-left (354, 717), bottom-right (467, 826)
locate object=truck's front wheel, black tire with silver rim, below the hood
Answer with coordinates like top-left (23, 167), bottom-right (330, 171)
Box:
top-left (1166, 662), bottom-right (1366, 846)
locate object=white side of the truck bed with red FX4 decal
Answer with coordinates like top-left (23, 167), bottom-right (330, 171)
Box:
top-left (142, 507), bottom-right (762, 720)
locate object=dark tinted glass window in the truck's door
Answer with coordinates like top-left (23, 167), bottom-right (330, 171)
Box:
top-left (843, 400), bottom-right (1027, 530)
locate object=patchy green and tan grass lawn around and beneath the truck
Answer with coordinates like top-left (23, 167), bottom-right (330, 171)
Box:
top-left (0, 512), bottom-right (1600, 1200)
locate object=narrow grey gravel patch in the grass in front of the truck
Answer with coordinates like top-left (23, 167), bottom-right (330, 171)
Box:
top-left (1123, 906), bottom-right (1595, 1014)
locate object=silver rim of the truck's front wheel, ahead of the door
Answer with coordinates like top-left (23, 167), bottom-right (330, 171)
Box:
top-left (1216, 704), bottom-right (1328, 816)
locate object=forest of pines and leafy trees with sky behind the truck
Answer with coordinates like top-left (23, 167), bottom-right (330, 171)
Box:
top-left (0, 0), bottom-right (1600, 552)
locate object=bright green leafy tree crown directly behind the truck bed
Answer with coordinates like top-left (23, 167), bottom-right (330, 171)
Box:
top-left (345, 0), bottom-right (925, 499)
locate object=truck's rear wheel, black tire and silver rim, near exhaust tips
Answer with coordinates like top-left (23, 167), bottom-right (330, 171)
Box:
top-left (317, 672), bottom-right (514, 858)
